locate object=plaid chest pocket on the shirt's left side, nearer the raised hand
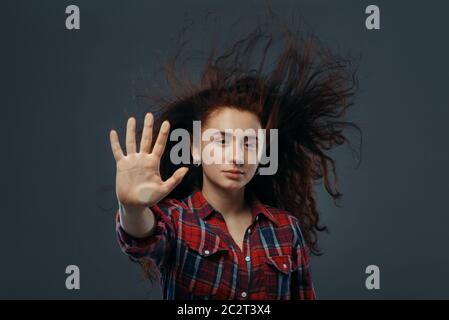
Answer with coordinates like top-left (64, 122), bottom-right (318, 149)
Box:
top-left (180, 232), bottom-right (228, 299)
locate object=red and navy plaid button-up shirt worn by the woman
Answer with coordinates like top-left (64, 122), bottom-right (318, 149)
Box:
top-left (116, 191), bottom-right (315, 300)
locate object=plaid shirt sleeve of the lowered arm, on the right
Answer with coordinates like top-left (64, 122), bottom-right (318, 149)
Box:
top-left (291, 220), bottom-right (316, 300)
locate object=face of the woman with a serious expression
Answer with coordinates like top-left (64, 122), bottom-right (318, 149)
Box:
top-left (194, 107), bottom-right (261, 191)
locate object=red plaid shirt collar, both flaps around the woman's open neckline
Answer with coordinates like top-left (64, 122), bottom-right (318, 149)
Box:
top-left (190, 190), bottom-right (279, 226)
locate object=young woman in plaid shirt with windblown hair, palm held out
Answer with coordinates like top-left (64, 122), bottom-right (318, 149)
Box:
top-left (110, 15), bottom-right (358, 299)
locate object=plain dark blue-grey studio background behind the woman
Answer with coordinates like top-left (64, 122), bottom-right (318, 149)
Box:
top-left (0, 0), bottom-right (449, 299)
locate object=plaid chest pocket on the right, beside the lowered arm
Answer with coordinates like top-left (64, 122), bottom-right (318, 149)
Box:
top-left (263, 254), bottom-right (294, 300)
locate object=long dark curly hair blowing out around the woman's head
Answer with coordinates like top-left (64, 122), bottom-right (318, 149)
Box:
top-left (133, 6), bottom-right (361, 282)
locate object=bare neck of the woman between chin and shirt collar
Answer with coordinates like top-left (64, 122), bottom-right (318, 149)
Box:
top-left (202, 179), bottom-right (246, 216)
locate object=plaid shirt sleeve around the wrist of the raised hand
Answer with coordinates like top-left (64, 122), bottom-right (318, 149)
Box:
top-left (116, 204), bottom-right (175, 269)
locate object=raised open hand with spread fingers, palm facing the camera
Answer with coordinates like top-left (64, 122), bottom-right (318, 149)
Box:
top-left (109, 113), bottom-right (188, 208)
